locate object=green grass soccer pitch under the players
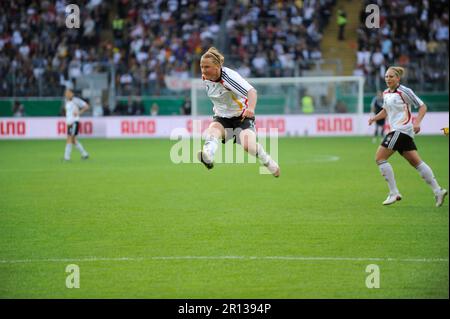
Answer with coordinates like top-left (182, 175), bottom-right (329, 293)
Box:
top-left (0, 136), bottom-right (449, 299)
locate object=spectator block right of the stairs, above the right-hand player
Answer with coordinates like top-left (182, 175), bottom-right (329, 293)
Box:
top-left (354, 0), bottom-right (449, 91)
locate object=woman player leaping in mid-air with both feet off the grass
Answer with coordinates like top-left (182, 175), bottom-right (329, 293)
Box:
top-left (198, 47), bottom-right (280, 177)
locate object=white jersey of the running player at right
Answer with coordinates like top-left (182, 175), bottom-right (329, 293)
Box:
top-left (383, 85), bottom-right (424, 138)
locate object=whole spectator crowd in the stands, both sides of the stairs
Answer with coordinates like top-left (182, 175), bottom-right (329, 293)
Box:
top-left (0, 0), bottom-right (448, 114)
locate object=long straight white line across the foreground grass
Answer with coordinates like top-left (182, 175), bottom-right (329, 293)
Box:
top-left (0, 256), bottom-right (448, 264)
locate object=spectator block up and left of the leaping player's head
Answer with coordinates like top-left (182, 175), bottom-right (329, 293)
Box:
top-left (112, 0), bottom-right (227, 95)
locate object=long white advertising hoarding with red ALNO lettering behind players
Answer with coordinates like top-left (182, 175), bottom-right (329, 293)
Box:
top-left (0, 112), bottom-right (449, 139)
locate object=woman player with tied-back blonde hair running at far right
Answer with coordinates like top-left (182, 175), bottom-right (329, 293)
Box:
top-left (369, 67), bottom-right (447, 207)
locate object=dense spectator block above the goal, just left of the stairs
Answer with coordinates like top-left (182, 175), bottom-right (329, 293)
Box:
top-left (225, 0), bottom-right (336, 77)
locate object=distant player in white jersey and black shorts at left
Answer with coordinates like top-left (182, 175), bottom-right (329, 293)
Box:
top-left (64, 88), bottom-right (89, 161)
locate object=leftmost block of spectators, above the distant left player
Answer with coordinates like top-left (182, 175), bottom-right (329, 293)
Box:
top-left (0, 0), bottom-right (110, 96)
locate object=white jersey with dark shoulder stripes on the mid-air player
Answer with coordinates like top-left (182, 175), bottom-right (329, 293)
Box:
top-left (203, 67), bottom-right (253, 118)
